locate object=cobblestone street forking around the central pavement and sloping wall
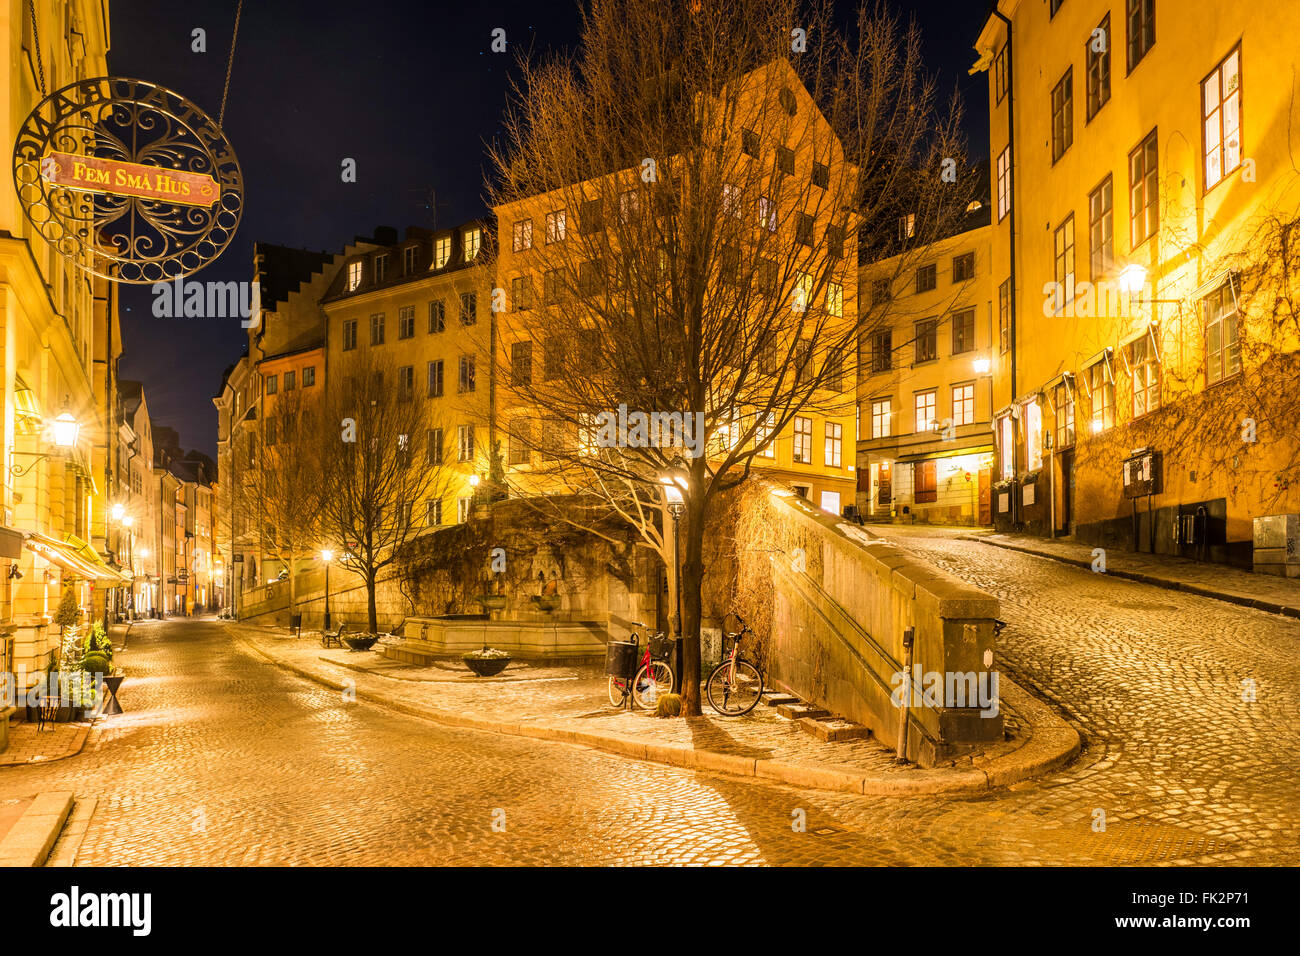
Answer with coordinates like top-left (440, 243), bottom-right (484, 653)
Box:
top-left (0, 529), bottom-right (1300, 865)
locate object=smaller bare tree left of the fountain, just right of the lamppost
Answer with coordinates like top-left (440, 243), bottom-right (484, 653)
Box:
top-left (313, 354), bottom-right (451, 632)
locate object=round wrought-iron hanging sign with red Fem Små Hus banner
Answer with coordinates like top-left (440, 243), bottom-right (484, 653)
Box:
top-left (13, 77), bottom-right (243, 285)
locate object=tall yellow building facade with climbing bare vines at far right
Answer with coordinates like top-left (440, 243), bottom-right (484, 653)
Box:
top-left (976, 0), bottom-right (1300, 564)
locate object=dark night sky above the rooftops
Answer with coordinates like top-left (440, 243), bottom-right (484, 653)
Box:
top-left (108, 0), bottom-right (988, 455)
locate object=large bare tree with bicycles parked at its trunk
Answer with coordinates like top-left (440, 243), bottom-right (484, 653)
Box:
top-left (493, 0), bottom-right (971, 714)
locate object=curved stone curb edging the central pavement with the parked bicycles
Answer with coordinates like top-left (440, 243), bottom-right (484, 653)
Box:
top-left (235, 635), bottom-right (1080, 796)
